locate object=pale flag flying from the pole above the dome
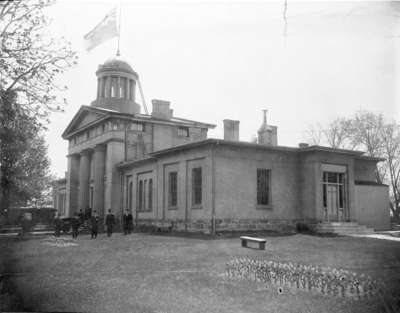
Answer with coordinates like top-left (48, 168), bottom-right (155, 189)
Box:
top-left (83, 8), bottom-right (118, 51)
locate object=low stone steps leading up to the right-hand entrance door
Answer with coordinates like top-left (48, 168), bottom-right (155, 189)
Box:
top-left (315, 222), bottom-right (375, 235)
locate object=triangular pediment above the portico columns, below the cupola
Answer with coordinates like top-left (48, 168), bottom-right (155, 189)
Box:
top-left (62, 106), bottom-right (110, 139)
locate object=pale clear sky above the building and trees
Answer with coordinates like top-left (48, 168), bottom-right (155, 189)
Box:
top-left (46, 0), bottom-right (400, 177)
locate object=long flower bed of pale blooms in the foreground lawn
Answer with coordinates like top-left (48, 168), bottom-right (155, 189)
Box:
top-left (226, 258), bottom-right (382, 299)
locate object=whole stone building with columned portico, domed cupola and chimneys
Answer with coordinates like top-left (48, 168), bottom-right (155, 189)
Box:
top-left (55, 58), bottom-right (389, 232)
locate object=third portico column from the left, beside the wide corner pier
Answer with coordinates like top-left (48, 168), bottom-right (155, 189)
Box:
top-left (92, 145), bottom-right (106, 216)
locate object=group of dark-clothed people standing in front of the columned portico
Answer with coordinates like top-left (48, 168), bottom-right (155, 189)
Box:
top-left (54, 209), bottom-right (133, 239)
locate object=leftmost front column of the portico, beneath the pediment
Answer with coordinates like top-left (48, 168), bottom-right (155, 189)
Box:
top-left (66, 154), bottom-right (80, 217)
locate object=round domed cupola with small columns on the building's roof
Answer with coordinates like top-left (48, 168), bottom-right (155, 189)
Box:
top-left (92, 56), bottom-right (140, 114)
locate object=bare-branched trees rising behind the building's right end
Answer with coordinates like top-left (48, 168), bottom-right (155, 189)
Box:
top-left (307, 111), bottom-right (400, 221)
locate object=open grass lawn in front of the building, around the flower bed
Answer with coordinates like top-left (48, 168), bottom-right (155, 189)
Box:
top-left (0, 234), bottom-right (400, 313)
